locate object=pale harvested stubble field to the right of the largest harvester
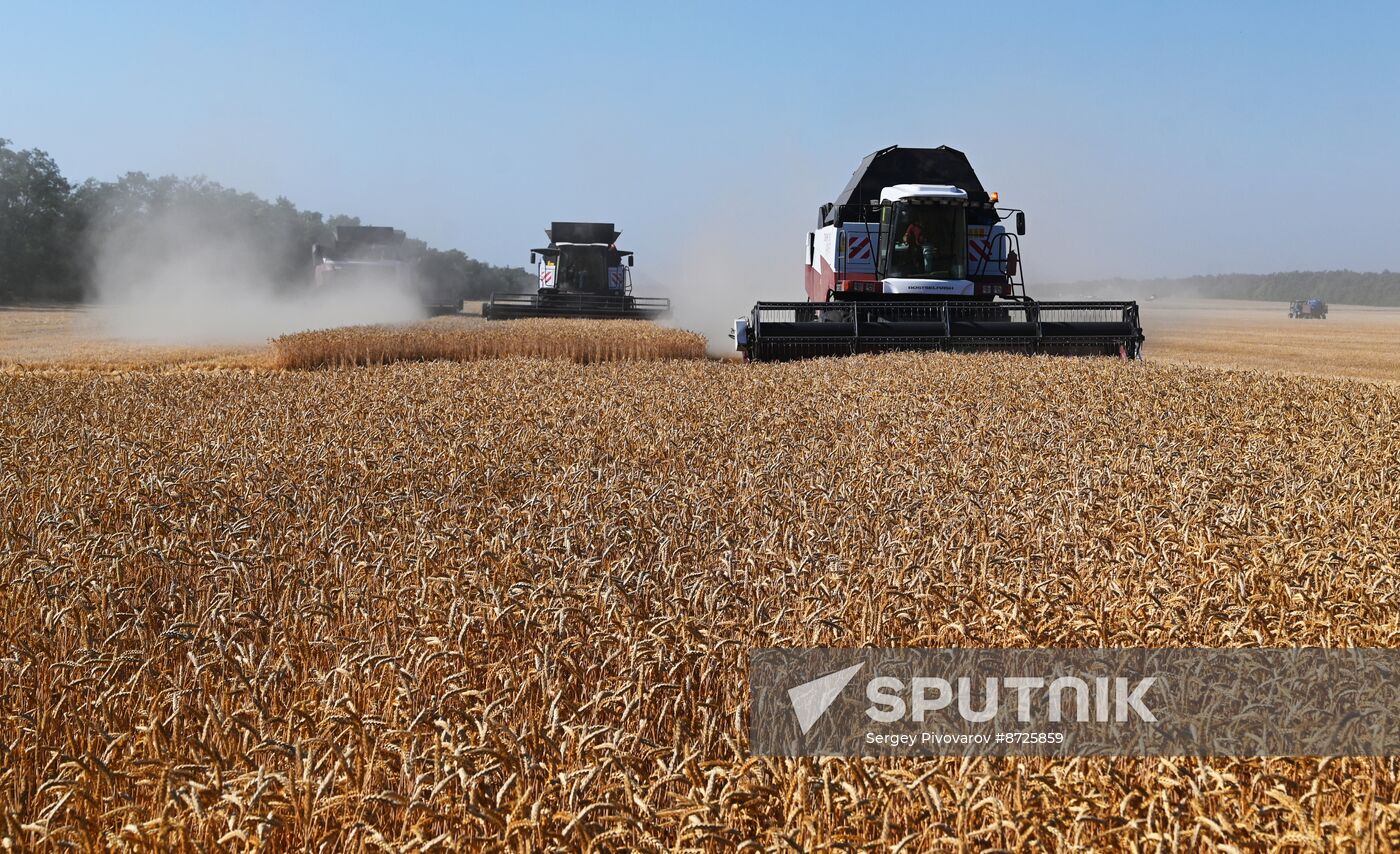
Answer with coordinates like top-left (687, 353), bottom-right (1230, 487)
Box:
top-left (1141, 298), bottom-right (1400, 381)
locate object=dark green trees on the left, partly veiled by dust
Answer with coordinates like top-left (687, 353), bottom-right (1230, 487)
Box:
top-left (0, 139), bottom-right (535, 305)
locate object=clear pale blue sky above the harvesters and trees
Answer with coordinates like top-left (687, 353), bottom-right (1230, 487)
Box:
top-left (0, 0), bottom-right (1400, 285)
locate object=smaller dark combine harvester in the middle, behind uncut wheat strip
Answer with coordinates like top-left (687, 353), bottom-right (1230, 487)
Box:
top-left (482, 223), bottom-right (671, 321)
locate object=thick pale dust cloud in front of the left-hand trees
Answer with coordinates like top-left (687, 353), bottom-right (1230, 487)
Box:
top-left (91, 210), bottom-right (424, 344)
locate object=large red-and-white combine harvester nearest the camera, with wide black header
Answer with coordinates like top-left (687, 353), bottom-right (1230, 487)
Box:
top-left (732, 146), bottom-right (1142, 361)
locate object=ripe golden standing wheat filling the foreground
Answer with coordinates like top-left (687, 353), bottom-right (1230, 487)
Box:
top-left (0, 348), bottom-right (1400, 851)
